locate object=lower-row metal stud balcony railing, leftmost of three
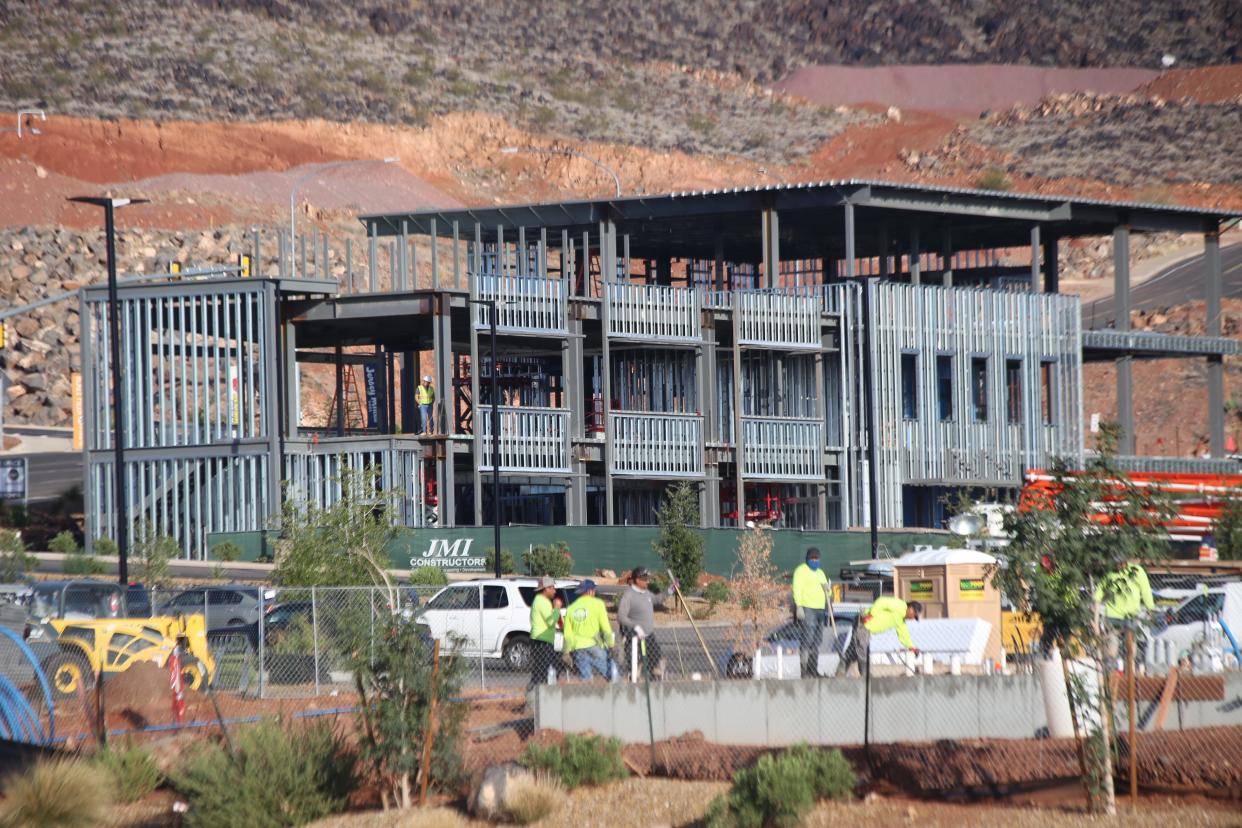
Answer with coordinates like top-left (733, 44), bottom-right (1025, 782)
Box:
top-left (476, 405), bottom-right (569, 473)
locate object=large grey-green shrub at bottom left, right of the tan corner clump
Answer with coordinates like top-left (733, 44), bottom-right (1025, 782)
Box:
top-left (173, 719), bottom-right (358, 828)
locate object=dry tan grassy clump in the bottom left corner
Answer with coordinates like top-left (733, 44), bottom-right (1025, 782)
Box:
top-left (0, 758), bottom-right (112, 828)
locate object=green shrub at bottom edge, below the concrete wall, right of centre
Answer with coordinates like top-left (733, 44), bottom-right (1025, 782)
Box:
top-left (704, 745), bottom-right (857, 828)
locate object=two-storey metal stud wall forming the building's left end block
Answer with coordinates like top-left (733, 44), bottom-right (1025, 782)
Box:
top-left (82, 279), bottom-right (274, 557)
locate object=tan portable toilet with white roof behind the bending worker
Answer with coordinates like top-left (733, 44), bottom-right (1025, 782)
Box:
top-left (893, 546), bottom-right (1001, 659)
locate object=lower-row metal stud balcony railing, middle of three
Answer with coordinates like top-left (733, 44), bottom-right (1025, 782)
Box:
top-left (609, 411), bottom-right (703, 477)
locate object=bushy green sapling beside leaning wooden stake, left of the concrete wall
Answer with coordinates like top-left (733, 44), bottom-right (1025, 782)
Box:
top-left (354, 617), bottom-right (467, 808)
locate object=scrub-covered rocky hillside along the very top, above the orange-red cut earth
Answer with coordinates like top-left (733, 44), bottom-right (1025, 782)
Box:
top-left (0, 0), bottom-right (1242, 161)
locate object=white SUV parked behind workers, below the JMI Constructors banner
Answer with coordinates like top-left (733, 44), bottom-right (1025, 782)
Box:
top-left (415, 577), bottom-right (578, 670)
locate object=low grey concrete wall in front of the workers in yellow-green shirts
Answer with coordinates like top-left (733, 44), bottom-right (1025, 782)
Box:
top-left (535, 674), bottom-right (1242, 745)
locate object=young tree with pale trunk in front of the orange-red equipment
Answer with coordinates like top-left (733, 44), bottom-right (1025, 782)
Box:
top-left (994, 426), bottom-right (1172, 814)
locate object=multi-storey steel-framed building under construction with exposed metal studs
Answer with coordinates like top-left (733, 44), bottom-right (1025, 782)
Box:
top-left (82, 181), bottom-right (1238, 555)
